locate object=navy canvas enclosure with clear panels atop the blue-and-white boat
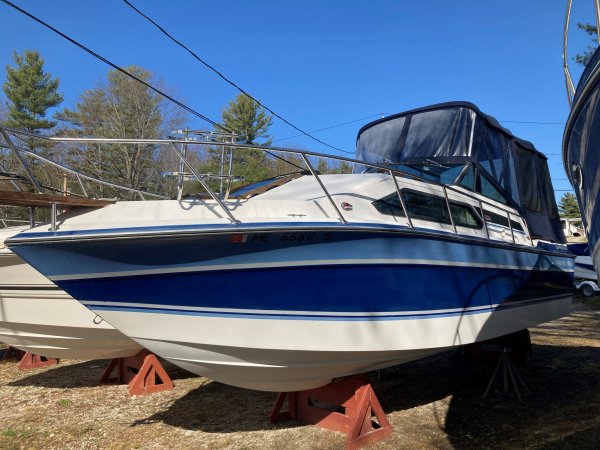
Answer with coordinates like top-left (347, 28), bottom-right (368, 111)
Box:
top-left (356, 102), bottom-right (565, 242)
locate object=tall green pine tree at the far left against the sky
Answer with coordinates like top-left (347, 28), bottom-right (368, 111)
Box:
top-left (3, 50), bottom-right (63, 133)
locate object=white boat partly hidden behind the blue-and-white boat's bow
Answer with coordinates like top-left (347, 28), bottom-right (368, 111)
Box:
top-left (0, 227), bottom-right (142, 359)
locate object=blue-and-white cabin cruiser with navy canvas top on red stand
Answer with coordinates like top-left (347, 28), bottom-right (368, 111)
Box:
top-left (7, 102), bottom-right (573, 391)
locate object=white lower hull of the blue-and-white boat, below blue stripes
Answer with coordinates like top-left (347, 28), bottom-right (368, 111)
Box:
top-left (95, 297), bottom-right (571, 391)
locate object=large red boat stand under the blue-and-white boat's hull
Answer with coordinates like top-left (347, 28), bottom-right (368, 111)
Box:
top-left (269, 375), bottom-right (392, 449)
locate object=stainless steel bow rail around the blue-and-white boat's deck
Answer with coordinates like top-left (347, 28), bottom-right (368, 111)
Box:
top-left (0, 127), bottom-right (533, 245)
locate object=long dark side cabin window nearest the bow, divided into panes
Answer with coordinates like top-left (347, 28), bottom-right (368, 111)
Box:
top-left (373, 190), bottom-right (483, 229)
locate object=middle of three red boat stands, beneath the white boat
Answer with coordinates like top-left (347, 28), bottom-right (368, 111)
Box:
top-left (100, 350), bottom-right (173, 395)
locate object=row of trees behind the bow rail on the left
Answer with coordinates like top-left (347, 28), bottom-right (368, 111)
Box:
top-left (0, 50), bottom-right (351, 207)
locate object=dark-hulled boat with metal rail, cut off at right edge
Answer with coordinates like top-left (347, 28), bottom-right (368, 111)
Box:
top-left (562, 0), bottom-right (600, 278)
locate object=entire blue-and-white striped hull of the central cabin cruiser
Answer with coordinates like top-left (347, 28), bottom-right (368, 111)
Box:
top-left (8, 227), bottom-right (573, 391)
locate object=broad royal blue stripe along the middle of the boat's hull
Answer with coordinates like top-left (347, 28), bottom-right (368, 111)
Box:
top-left (57, 265), bottom-right (572, 313)
